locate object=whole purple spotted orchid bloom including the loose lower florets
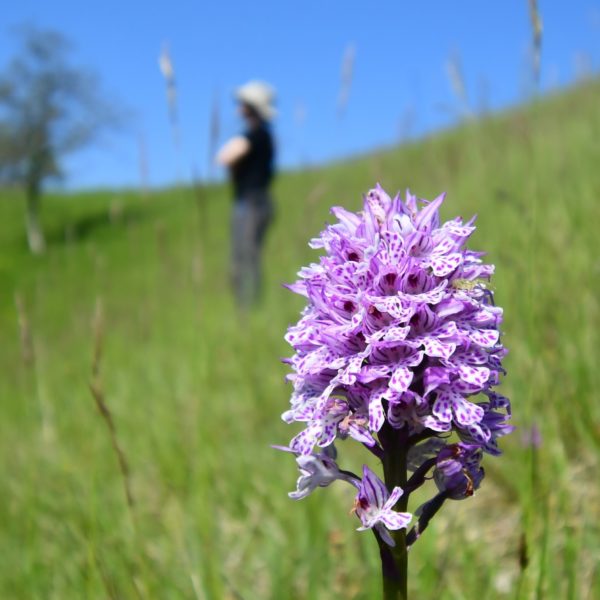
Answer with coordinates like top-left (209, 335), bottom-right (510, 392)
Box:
top-left (283, 186), bottom-right (512, 545)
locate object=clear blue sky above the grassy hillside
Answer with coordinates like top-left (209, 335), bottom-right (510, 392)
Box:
top-left (0, 0), bottom-right (600, 188)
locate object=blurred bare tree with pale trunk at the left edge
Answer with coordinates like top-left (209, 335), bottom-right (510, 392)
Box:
top-left (0, 27), bottom-right (119, 254)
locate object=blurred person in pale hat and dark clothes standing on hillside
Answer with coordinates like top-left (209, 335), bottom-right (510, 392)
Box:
top-left (217, 81), bottom-right (276, 307)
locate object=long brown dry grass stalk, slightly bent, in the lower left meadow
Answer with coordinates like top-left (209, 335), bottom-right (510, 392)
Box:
top-left (90, 298), bottom-right (134, 510)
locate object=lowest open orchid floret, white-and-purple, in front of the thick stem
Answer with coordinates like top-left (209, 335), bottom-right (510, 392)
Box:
top-left (354, 465), bottom-right (412, 546)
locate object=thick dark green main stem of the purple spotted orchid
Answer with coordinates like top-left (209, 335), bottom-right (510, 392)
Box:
top-left (378, 423), bottom-right (408, 600)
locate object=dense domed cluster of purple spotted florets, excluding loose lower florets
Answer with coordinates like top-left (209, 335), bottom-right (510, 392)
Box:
top-left (284, 187), bottom-right (509, 454)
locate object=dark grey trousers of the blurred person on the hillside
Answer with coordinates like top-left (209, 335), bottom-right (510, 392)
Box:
top-left (231, 190), bottom-right (273, 307)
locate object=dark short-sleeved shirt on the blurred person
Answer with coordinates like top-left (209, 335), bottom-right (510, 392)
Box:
top-left (231, 123), bottom-right (275, 200)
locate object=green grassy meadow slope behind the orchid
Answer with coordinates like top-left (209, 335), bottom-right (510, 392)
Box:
top-left (0, 82), bottom-right (600, 600)
